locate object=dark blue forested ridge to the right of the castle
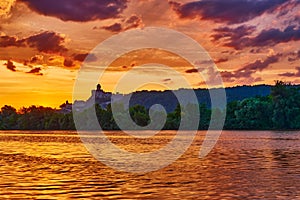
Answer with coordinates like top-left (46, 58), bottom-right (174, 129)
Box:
top-left (126, 85), bottom-right (272, 112)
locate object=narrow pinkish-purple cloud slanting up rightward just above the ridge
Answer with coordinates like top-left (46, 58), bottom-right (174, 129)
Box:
top-left (221, 54), bottom-right (282, 82)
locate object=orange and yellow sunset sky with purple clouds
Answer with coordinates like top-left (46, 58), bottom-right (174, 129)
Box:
top-left (0, 0), bottom-right (300, 108)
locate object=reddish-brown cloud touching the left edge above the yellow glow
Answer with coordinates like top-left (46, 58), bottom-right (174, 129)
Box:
top-left (0, 31), bottom-right (67, 53)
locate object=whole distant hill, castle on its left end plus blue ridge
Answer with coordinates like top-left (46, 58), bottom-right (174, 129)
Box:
top-left (74, 84), bottom-right (300, 113)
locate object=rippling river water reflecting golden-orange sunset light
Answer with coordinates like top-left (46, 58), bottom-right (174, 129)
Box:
top-left (0, 131), bottom-right (300, 199)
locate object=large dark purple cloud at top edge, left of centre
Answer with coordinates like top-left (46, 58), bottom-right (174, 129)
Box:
top-left (19, 0), bottom-right (127, 22)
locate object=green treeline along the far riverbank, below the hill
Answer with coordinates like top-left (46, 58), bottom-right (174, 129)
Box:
top-left (0, 81), bottom-right (300, 130)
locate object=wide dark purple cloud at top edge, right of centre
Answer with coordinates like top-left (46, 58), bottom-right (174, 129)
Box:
top-left (170, 0), bottom-right (288, 24)
